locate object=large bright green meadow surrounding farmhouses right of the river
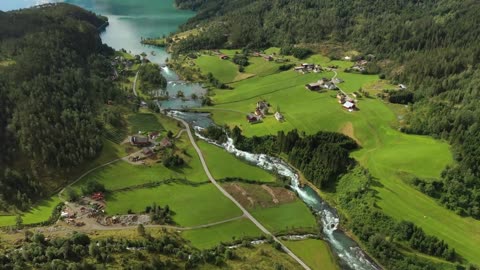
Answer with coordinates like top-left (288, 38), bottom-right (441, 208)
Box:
top-left (193, 50), bottom-right (480, 264)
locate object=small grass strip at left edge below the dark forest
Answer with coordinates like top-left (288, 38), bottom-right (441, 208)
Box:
top-left (0, 196), bottom-right (60, 227)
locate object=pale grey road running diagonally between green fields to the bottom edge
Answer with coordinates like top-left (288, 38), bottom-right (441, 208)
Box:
top-left (173, 117), bottom-right (310, 270)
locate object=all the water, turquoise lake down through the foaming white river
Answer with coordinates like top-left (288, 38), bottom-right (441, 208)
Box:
top-left (0, 0), bottom-right (378, 270)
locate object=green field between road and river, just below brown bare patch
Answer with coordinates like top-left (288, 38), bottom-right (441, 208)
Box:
top-left (251, 200), bottom-right (318, 233)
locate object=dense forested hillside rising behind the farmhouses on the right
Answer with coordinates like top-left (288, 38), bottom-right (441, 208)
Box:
top-left (173, 0), bottom-right (480, 219)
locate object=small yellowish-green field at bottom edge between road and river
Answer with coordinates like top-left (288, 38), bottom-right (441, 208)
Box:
top-left (283, 239), bottom-right (340, 270)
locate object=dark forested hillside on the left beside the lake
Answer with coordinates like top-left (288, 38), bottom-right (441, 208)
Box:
top-left (0, 4), bottom-right (120, 211)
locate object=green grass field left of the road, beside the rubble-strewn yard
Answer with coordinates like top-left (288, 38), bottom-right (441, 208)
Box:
top-left (106, 183), bottom-right (246, 226)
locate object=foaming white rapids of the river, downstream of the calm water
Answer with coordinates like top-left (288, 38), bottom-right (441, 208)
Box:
top-left (171, 111), bottom-right (380, 270)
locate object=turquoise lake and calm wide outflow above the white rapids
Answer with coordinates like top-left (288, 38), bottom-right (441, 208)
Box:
top-left (0, 0), bottom-right (206, 109)
